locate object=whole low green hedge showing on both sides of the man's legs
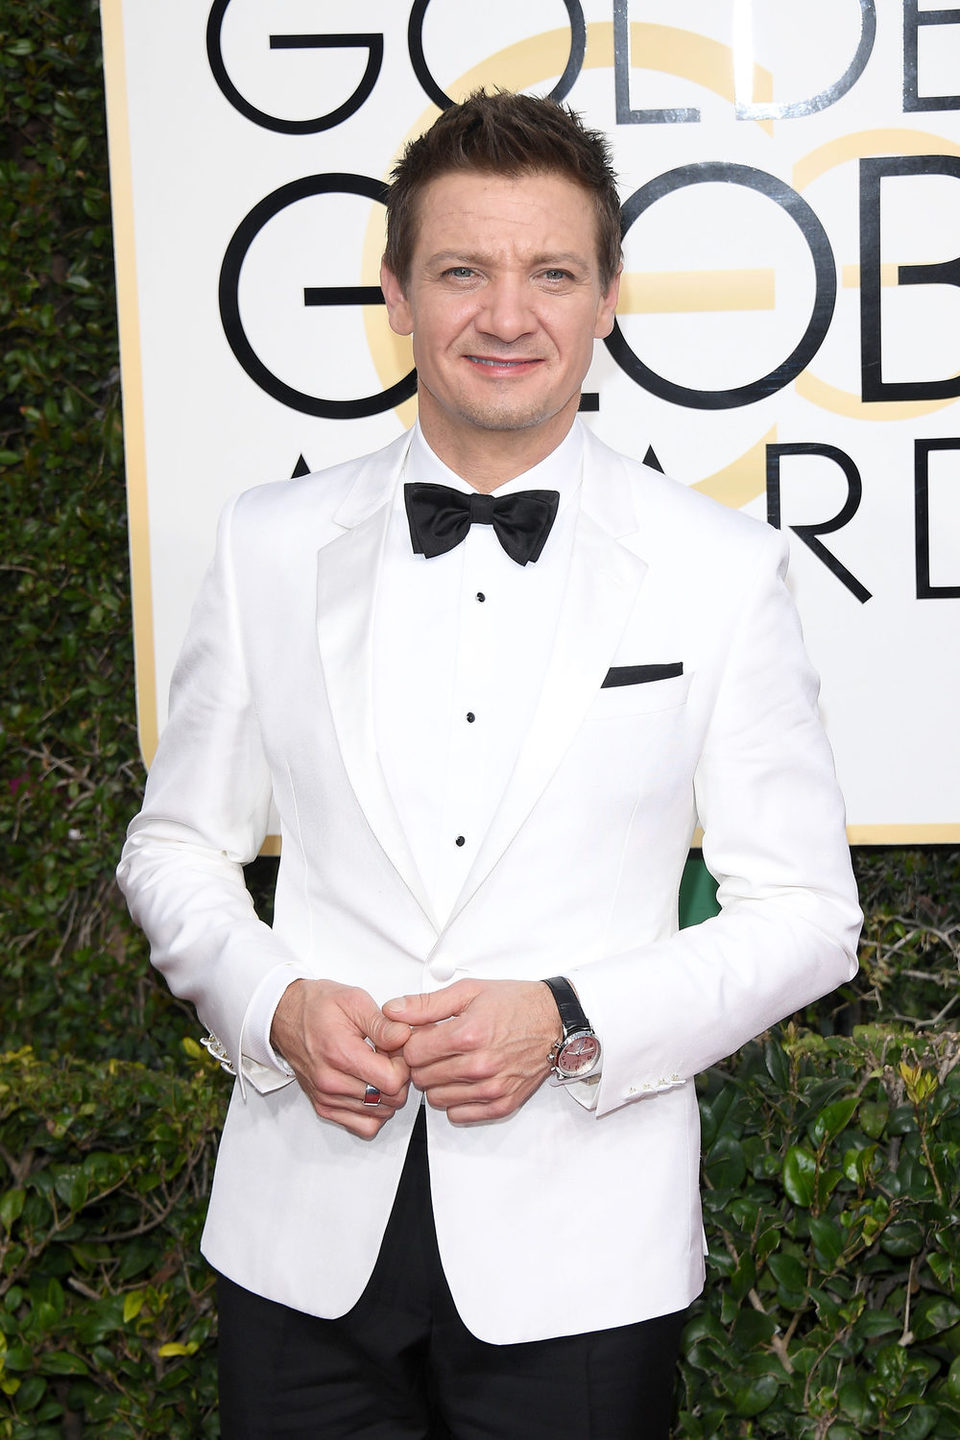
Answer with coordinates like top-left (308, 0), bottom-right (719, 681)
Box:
top-left (0, 1027), bottom-right (960, 1440)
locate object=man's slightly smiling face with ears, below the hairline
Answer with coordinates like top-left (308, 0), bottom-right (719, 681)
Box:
top-left (381, 171), bottom-right (619, 464)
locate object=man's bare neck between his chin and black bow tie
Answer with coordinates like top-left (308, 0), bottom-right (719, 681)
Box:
top-left (419, 395), bottom-right (580, 495)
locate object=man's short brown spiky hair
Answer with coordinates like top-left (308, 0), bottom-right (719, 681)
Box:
top-left (384, 89), bottom-right (620, 289)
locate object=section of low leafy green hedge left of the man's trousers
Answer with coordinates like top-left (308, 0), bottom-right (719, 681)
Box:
top-left (0, 1047), bottom-right (227, 1440)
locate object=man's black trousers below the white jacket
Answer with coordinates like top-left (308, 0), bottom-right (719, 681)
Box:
top-left (217, 1115), bottom-right (684, 1440)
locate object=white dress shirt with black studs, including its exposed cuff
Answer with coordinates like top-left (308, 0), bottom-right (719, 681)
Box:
top-left (243, 420), bottom-right (583, 1074)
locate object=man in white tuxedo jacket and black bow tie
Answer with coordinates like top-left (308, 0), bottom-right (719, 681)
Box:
top-left (119, 94), bottom-right (859, 1440)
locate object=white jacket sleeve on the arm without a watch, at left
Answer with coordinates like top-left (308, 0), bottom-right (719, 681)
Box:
top-left (117, 505), bottom-right (307, 1092)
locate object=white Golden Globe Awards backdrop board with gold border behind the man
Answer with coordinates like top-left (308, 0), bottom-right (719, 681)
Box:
top-left (102, 0), bottom-right (960, 842)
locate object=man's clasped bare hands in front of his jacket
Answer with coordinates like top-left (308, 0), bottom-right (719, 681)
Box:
top-left (271, 979), bottom-right (560, 1139)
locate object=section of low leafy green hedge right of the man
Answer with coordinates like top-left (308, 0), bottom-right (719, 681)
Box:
top-left (678, 1027), bottom-right (960, 1440)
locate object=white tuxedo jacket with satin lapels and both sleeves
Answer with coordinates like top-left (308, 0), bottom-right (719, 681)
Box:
top-left (118, 420), bottom-right (861, 1342)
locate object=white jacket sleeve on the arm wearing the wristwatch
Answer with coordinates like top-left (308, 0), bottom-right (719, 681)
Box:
top-left (569, 531), bottom-right (862, 1116)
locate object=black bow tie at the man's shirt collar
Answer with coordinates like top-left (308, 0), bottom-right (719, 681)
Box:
top-left (403, 484), bottom-right (560, 564)
